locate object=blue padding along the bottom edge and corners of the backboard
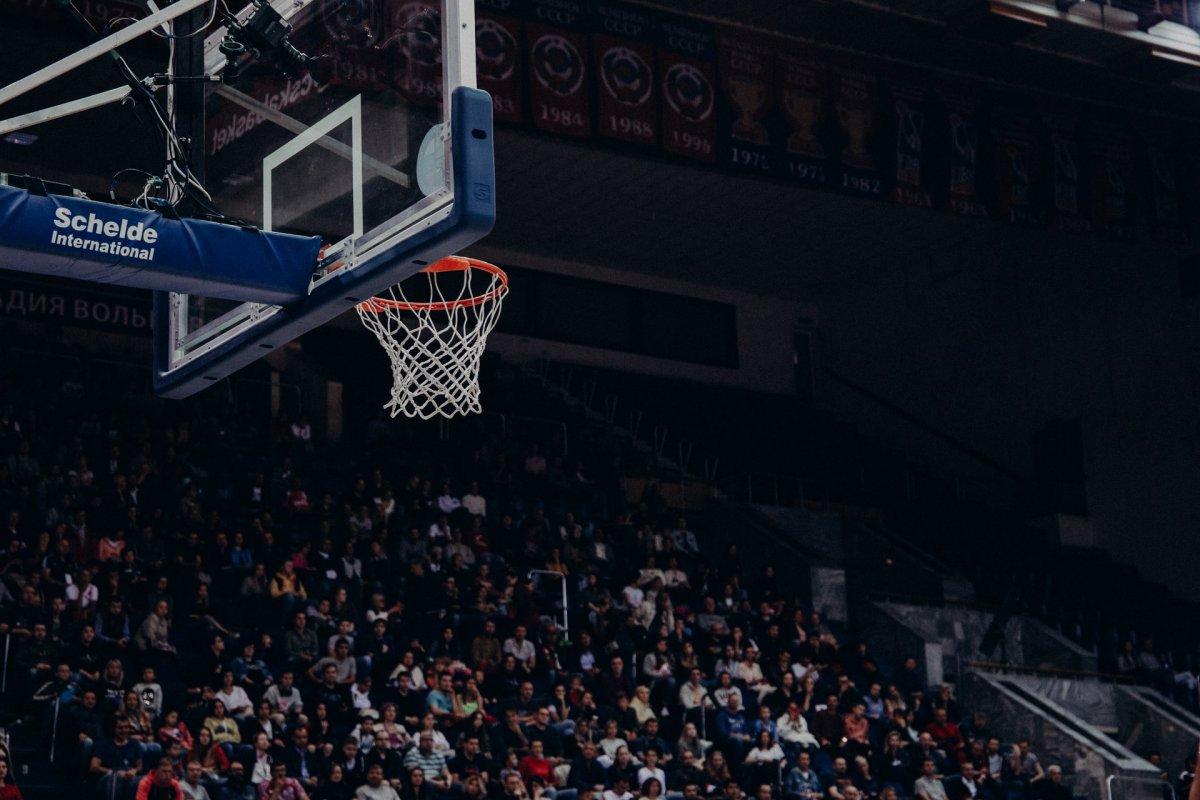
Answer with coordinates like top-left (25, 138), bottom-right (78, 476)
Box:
top-left (154, 86), bottom-right (496, 398)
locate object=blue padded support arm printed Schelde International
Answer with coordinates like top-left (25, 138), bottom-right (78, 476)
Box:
top-left (0, 186), bottom-right (322, 303)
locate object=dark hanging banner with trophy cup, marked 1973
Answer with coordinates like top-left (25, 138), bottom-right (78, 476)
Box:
top-left (775, 42), bottom-right (830, 186)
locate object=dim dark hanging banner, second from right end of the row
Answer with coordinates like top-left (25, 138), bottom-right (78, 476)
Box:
top-left (1085, 108), bottom-right (1138, 241)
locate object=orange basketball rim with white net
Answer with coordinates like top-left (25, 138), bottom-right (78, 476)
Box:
top-left (358, 255), bottom-right (509, 420)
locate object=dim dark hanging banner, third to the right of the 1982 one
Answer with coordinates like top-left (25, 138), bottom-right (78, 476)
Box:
top-left (991, 107), bottom-right (1048, 228)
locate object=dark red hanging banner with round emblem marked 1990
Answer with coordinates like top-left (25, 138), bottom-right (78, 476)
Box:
top-left (656, 17), bottom-right (716, 163)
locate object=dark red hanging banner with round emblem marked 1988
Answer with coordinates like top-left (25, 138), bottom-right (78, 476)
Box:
top-left (592, 1), bottom-right (659, 146)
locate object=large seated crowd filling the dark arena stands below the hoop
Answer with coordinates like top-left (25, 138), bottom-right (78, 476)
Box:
top-left (0, 367), bottom-right (1070, 800)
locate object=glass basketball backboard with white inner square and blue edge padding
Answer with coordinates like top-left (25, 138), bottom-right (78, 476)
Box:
top-left (155, 0), bottom-right (494, 397)
